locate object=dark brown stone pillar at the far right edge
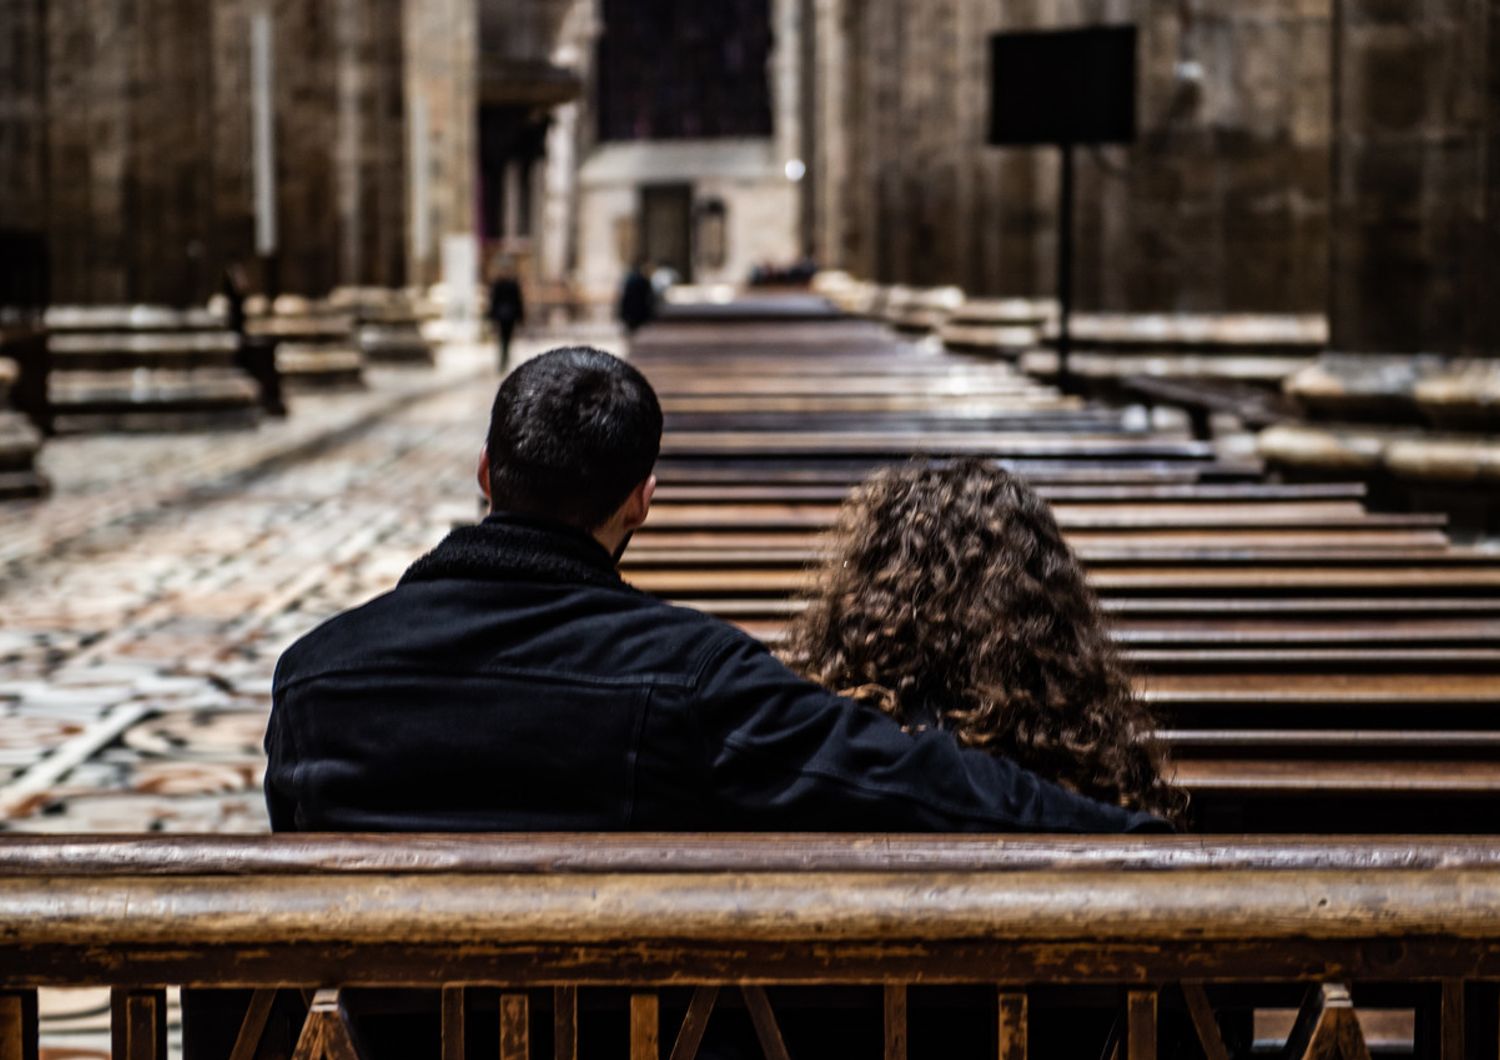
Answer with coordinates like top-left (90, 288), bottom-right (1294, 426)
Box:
top-left (1329, 0), bottom-right (1500, 354)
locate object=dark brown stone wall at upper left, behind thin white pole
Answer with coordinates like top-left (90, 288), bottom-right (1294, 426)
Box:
top-left (0, 0), bottom-right (417, 304)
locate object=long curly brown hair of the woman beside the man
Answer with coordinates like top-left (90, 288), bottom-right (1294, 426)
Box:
top-left (782, 460), bottom-right (1187, 822)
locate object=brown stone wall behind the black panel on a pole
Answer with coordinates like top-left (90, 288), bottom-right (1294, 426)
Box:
top-left (813, 0), bottom-right (1332, 310)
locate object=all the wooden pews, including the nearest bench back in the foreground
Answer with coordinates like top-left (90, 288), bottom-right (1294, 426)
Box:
top-left (0, 293), bottom-right (1500, 1060)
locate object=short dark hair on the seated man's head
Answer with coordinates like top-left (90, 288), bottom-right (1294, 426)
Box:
top-left (488, 346), bottom-right (662, 531)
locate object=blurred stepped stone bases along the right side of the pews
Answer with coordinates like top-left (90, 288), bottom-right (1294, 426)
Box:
top-left (815, 273), bottom-right (1500, 535)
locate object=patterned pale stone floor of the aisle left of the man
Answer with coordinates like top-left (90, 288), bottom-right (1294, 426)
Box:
top-left (0, 334), bottom-right (612, 832)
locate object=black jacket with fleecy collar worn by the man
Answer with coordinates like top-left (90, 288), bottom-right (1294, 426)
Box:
top-left (266, 516), bottom-right (1161, 832)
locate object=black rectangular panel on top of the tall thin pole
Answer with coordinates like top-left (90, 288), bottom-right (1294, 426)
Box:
top-left (990, 25), bottom-right (1137, 147)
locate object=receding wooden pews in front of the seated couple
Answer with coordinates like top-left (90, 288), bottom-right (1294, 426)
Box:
top-left (626, 298), bottom-right (1500, 832)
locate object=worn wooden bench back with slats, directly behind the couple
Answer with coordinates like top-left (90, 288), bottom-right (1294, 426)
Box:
top-left (0, 835), bottom-right (1500, 1060)
